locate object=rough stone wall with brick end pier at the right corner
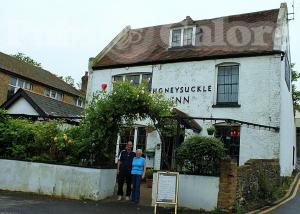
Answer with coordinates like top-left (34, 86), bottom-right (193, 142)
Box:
top-left (218, 159), bottom-right (281, 211)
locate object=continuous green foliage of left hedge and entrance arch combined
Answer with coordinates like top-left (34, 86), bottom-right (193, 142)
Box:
top-left (0, 82), bottom-right (173, 166)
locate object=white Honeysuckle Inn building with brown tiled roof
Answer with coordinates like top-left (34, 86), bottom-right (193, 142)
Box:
top-left (87, 3), bottom-right (296, 176)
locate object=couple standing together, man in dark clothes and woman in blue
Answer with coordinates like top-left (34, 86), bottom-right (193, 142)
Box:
top-left (117, 141), bottom-right (146, 203)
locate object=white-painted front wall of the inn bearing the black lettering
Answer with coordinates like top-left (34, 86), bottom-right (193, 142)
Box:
top-left (87, 55), bottom-right (284, 170)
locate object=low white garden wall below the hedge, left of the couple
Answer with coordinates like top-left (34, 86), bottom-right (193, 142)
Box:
top-left (0, 159), bottom-right (116, 200)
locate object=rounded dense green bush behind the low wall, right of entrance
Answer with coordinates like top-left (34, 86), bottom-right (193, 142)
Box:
top-left (176, 135), bottom-right (225, 175)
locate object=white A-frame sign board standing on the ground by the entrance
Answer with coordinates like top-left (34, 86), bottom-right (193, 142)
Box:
top-left (154, 172), bottom-right (179, 214)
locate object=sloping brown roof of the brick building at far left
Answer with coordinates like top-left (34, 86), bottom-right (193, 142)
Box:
top-left (0, 52), bottom-right (82, 96)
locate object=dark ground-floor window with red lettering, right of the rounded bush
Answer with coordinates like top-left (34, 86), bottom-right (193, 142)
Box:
top-left (215, 125), bottom-right (240, 164)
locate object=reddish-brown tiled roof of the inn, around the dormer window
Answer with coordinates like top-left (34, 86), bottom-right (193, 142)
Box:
top-left (93, 9), bottom-right (280, 69)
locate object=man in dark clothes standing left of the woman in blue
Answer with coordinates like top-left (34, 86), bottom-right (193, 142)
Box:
top-left (117, 141), bottom-right (135, 201)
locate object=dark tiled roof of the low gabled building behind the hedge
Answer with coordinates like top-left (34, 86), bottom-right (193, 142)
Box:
top-left (1, 88), bottom-right (83, 117)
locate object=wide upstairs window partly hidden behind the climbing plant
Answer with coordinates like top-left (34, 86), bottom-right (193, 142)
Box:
top-left (113, 73), bottom-right (152, 91)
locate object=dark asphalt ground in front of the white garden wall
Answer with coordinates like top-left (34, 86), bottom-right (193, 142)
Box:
top-left (0, 191), bottom-right (199, 214)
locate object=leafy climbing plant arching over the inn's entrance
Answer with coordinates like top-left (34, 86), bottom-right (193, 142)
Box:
top-left (83, 82), bottom-right (173, 164)
